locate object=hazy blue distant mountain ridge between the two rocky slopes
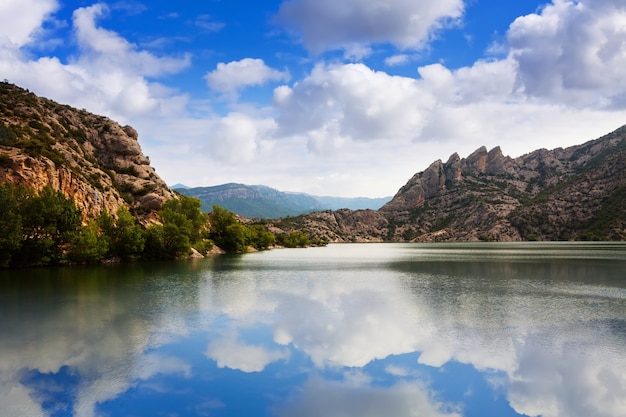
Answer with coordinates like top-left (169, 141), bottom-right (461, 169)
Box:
top-left (172, 183), bottom-right (391, 219)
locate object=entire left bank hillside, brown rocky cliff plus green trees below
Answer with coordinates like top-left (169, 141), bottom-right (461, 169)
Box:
top-left (0, 82), bottom-right (323, 268)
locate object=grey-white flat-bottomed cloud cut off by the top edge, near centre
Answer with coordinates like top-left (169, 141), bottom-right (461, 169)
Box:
top-left (276, 0), bottom-right (464, 53)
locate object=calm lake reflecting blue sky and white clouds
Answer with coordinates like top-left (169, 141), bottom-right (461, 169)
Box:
top-left (0, 242), bottom-right (626, 417)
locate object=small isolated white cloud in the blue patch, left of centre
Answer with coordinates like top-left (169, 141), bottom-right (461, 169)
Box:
top-left (205, 58), bottom-right (289, 94)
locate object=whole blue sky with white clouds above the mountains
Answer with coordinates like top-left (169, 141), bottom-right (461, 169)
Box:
top-left (0, 0), bottom-right (626, 197)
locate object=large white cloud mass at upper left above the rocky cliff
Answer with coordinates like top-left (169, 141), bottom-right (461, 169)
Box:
top-left (0, 2), bottom-right (191, 122)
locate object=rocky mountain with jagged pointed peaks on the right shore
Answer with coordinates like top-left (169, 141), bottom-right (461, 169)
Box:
top-left (277, 126), bottom-right (626, 242)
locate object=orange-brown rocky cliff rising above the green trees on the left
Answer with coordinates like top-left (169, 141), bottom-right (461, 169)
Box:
top-left (0, 83), bottom-right (174, 224)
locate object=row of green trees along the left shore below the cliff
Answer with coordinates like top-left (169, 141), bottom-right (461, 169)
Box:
top-left (0, 183), bottom-right (310, 268)
